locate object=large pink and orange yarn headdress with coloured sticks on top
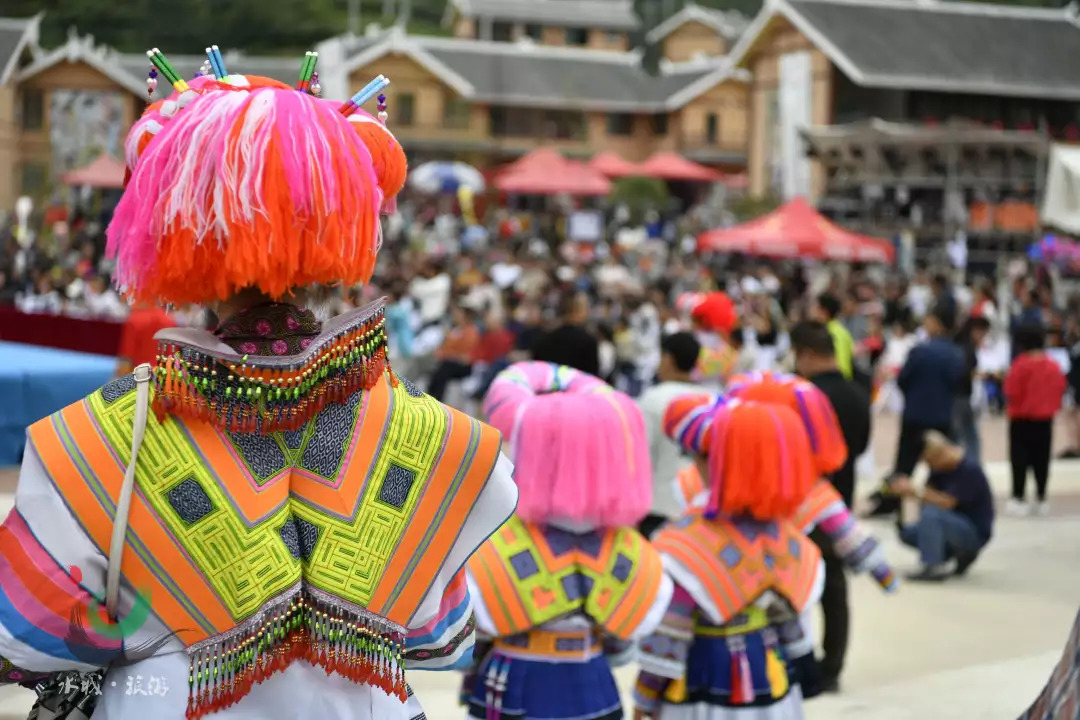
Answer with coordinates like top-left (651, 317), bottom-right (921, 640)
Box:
top-left (108, 45), bottom-right (406, 304)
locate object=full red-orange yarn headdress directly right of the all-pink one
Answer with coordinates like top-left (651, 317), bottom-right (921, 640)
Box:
top-left (664, 395), bottom-right (816, 520)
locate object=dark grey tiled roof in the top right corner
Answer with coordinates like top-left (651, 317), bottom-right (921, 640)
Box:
top-left (735, 0), bottom-right (1080, 99)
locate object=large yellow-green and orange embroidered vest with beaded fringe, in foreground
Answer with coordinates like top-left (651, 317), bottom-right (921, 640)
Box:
top-left (29, 303), bottom-right (501, 718)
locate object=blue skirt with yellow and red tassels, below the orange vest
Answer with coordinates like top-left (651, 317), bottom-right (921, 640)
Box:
top-left (657, 629), bottom-right (804, 720)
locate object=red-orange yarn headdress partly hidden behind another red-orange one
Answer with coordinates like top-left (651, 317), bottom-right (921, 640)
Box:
top-left (727, 371), bottom-right (848, 476)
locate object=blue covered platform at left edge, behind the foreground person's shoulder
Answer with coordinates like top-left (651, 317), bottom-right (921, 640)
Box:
top-left (0, 341), bottom-right (117, 467)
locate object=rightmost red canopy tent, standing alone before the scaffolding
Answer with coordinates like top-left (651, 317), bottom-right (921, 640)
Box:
top-left (698, 198), bottom-right (895, 262)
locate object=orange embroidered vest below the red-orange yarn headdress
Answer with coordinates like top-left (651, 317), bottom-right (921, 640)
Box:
top-left (652, 516), bottom-right (821, 623)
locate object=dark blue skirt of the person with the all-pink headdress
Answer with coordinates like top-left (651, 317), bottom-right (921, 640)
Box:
top-left (469, 652), bottom-right (623, 720)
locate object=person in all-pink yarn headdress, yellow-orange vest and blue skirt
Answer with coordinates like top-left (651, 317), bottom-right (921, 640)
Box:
top-left (465, 363), bottom-right (672, 720)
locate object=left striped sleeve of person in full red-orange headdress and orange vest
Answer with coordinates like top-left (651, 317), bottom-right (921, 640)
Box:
top-left (634, 585), bottom-right (697, 712)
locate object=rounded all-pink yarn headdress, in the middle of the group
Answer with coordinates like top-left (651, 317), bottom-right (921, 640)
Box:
top-left (484, 362), bottom-right (652, 528)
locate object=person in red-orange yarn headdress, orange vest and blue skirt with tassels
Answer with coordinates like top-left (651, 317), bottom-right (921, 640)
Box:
top-left (634, 395), bottom-right (824, 720)
